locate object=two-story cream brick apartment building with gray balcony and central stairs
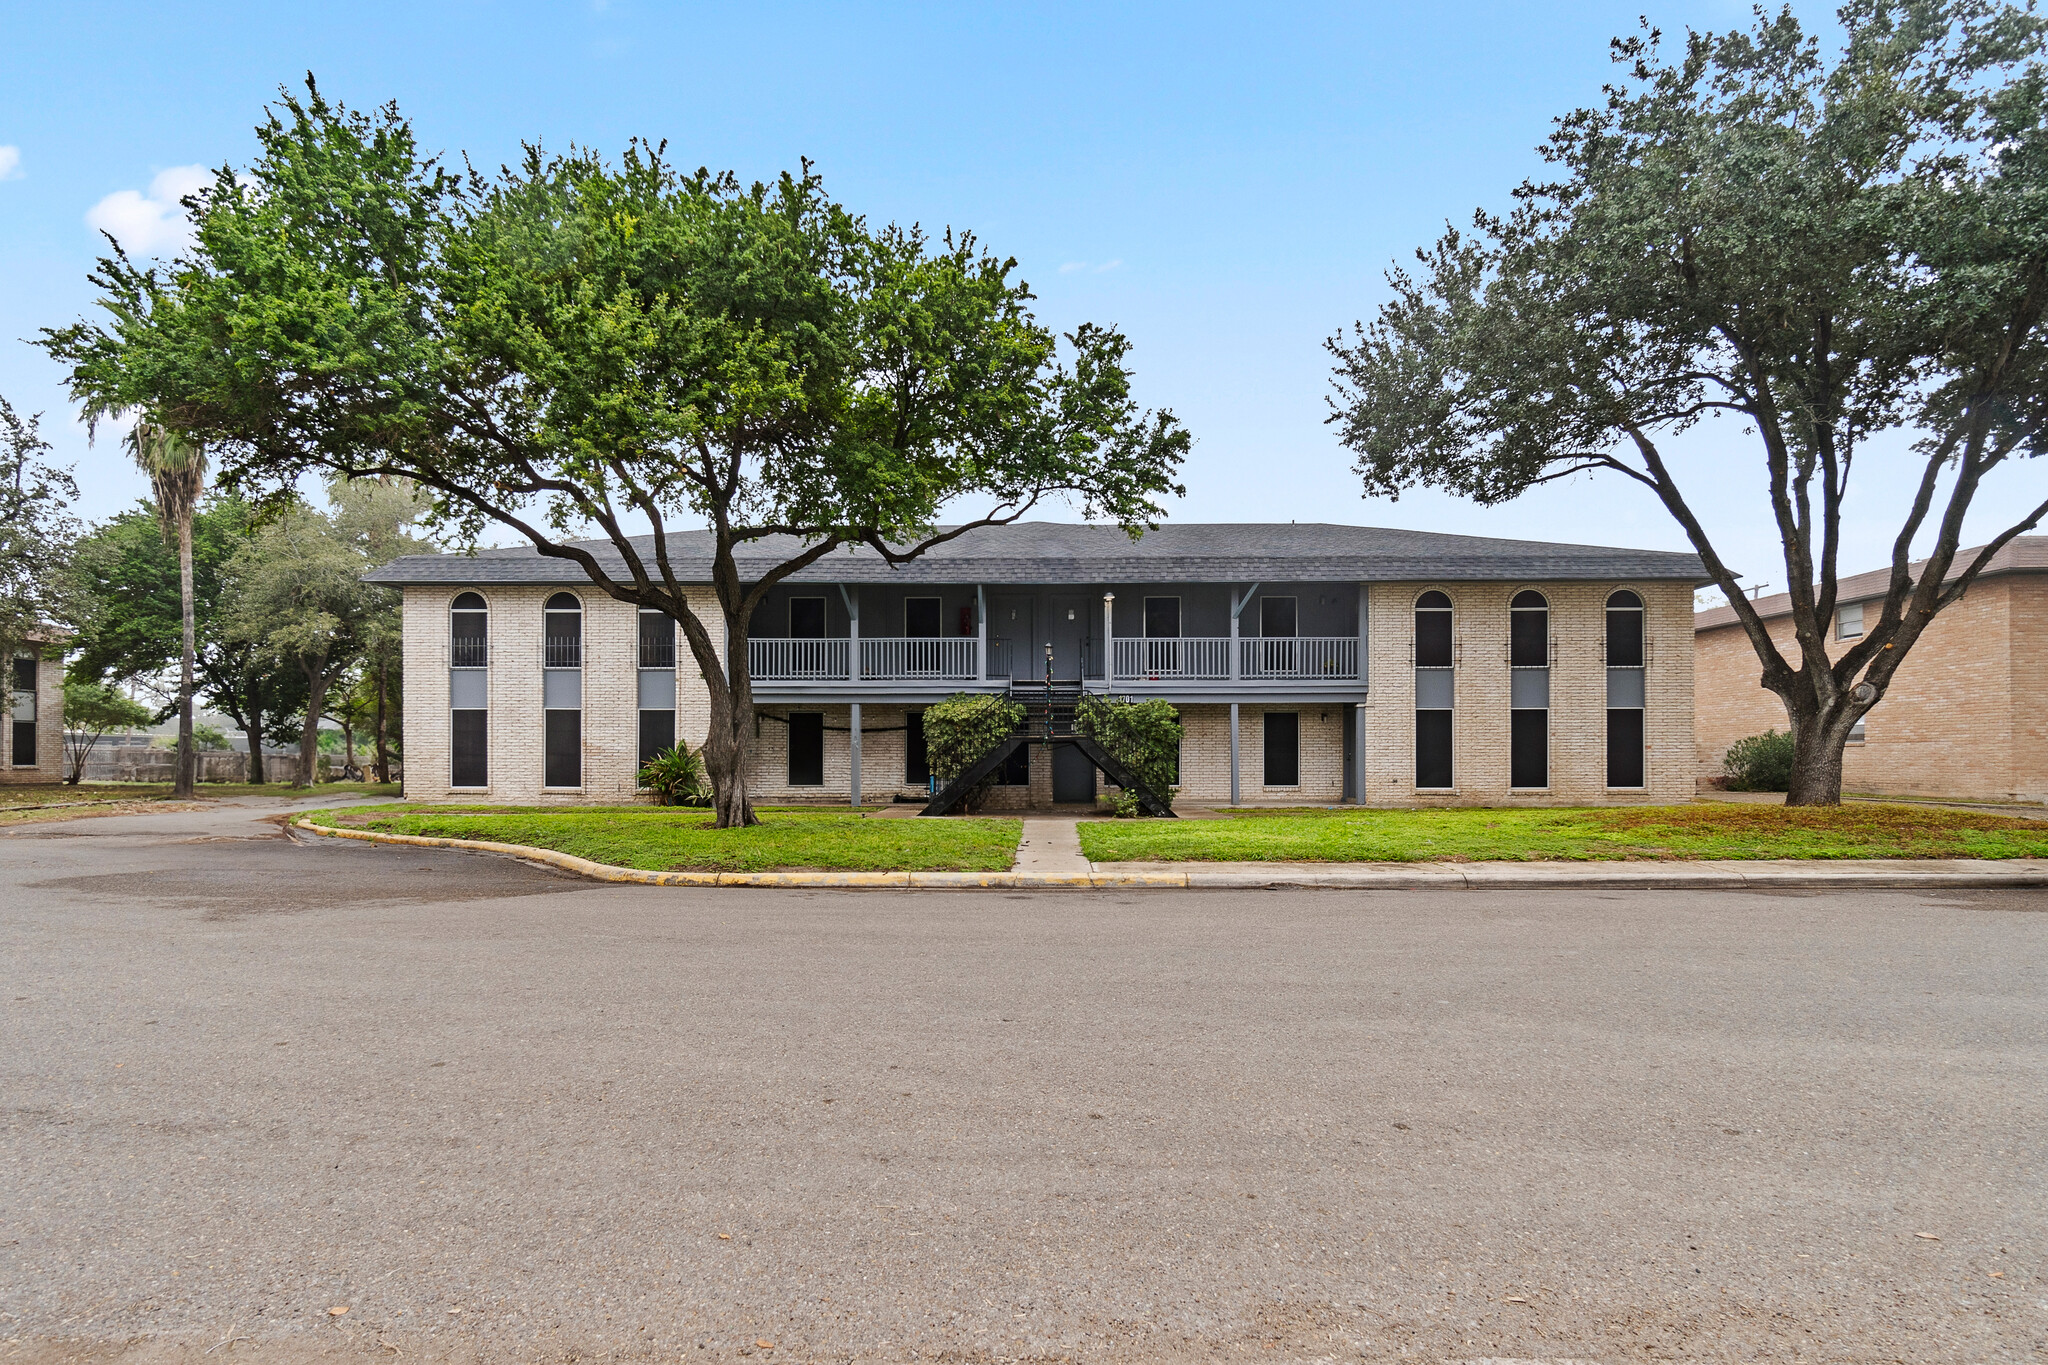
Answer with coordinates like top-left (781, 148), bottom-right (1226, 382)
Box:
top-left (371, 522), bottom-right (1702, 808)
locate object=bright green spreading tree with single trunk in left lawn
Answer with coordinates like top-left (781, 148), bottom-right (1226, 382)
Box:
top-left (45, 82), bottom-right (1188, 825)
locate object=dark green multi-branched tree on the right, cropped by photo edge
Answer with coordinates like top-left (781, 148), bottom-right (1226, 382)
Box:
top-left (1331, 0), bottom-right (2048, 804)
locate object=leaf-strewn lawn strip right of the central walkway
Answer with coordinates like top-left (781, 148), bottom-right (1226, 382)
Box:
top-left (1081, 802), bottom-right (2048, 862)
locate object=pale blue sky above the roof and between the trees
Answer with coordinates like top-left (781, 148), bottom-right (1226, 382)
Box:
top-left (0, 0), bottom-right (2017, 585)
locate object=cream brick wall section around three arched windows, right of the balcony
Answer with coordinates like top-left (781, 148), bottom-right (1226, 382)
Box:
top-left (1366, 583), bottom-right (1694, 806)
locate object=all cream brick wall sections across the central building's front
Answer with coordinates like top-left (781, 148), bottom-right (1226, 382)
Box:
top-left (406, 583), bottom-right (1694, 810)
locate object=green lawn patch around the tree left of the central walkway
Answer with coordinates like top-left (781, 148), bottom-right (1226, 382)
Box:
top-left (324, 806), bottom-right (1022, 872)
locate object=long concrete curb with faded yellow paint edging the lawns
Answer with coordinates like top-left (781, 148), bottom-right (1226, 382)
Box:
top-left (291, 814), bottom-right (2048, 890)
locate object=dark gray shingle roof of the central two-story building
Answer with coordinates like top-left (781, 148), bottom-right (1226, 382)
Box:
top-left (367, 522), bottom-right (1706, 585)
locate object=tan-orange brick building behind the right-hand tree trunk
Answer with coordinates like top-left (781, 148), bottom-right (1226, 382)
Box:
top-left (1694, 536), bottom-right (2048, 800)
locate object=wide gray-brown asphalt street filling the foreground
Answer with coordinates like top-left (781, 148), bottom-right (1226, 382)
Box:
top-left (0, 804), bottom-right (2048, 1365)
